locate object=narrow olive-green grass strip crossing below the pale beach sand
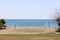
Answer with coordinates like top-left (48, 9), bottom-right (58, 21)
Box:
top-left (0, 34), bottom-right (60, 37)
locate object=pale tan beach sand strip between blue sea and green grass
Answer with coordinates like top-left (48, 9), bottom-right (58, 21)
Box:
top-left (0, 28), bottom-right (56, 34)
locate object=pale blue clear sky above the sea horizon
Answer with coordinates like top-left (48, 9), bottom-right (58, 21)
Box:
top-left (0, 0), bottom-right (60, 19)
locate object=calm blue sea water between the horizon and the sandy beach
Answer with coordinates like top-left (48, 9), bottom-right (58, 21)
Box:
top-left (5, 19), bottom-right (57, 28)
